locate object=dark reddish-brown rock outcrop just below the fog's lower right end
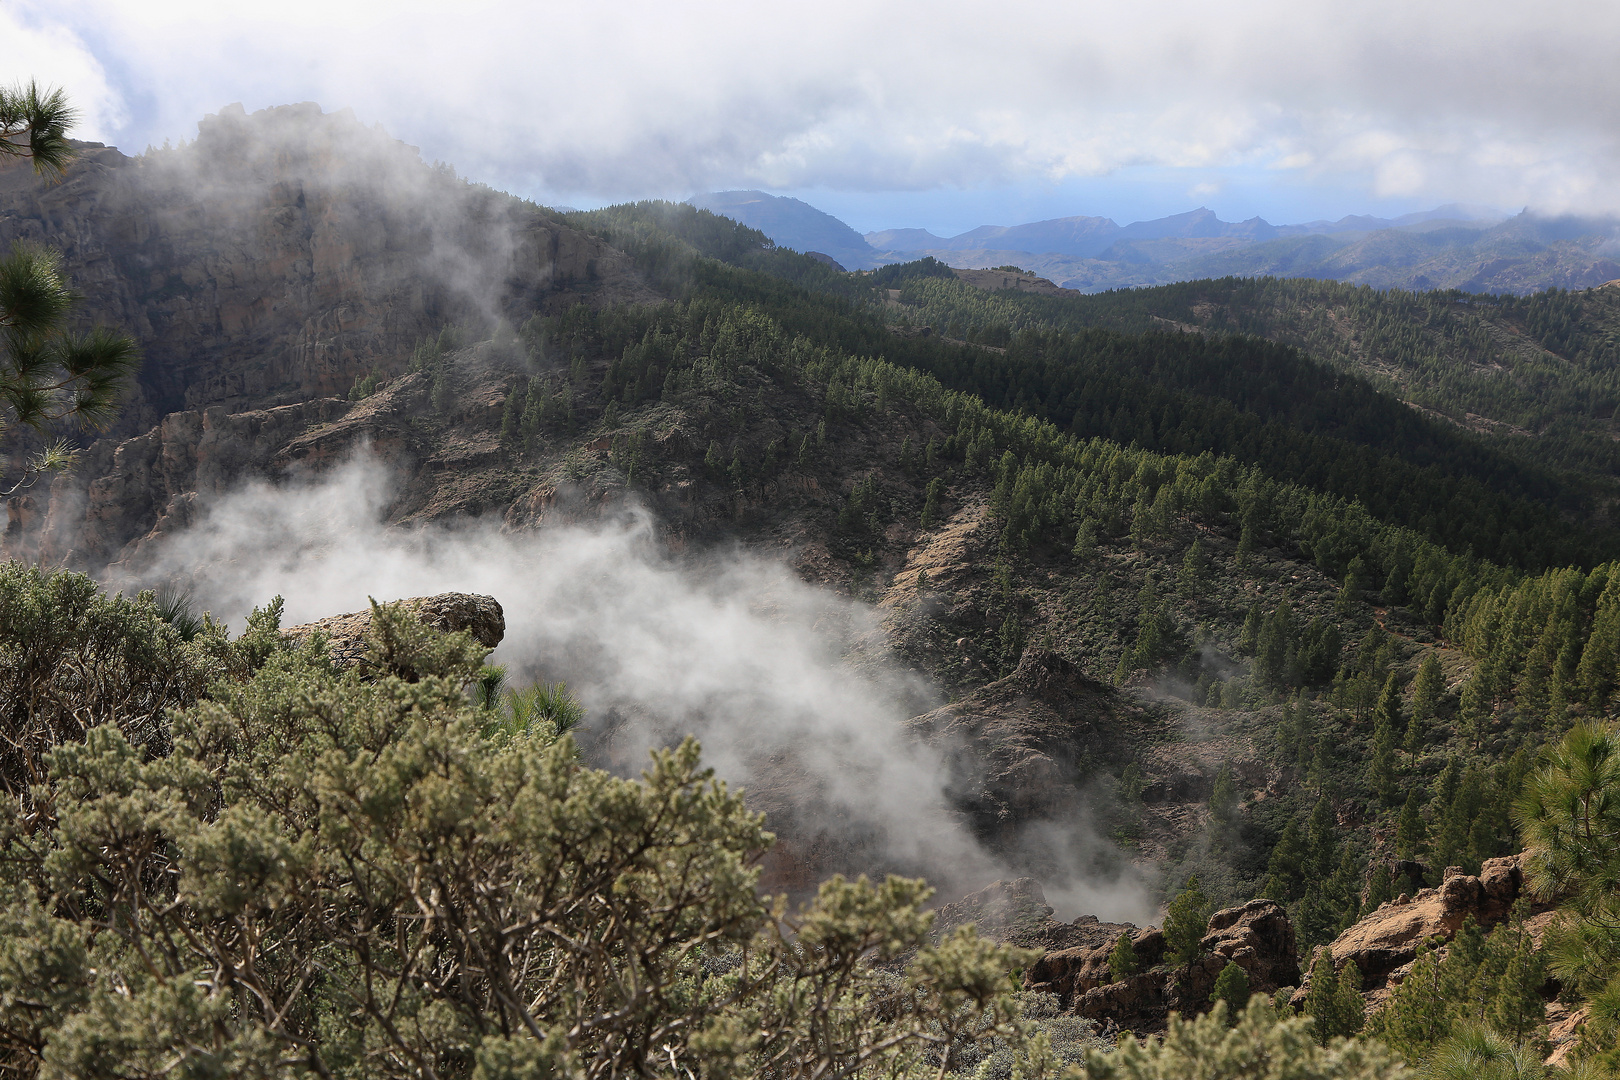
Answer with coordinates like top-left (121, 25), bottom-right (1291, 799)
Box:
top-left (1024, 900), bottom-right (1299, 1031)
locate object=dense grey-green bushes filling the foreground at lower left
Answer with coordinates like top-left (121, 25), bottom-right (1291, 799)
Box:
top-left (0, 563), bottom-right (1438, 1078)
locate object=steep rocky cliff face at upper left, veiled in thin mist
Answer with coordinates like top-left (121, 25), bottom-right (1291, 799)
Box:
top-left (0, 105), bottom-right (653, 436)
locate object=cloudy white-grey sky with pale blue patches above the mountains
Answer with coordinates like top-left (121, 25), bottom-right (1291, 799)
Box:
top-left (0, 0), bottom-right (1620, 232)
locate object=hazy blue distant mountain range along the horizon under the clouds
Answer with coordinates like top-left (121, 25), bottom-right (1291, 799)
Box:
top-left (690, 191), bottom-right (1620, 293)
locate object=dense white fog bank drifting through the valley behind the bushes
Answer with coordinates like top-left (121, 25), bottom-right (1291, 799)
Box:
top-left (113, 455), bottom-right (1155, 923)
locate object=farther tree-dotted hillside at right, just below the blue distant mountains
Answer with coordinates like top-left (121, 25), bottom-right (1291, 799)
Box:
top-left (906, 275), bottom-right (1620, 476)
